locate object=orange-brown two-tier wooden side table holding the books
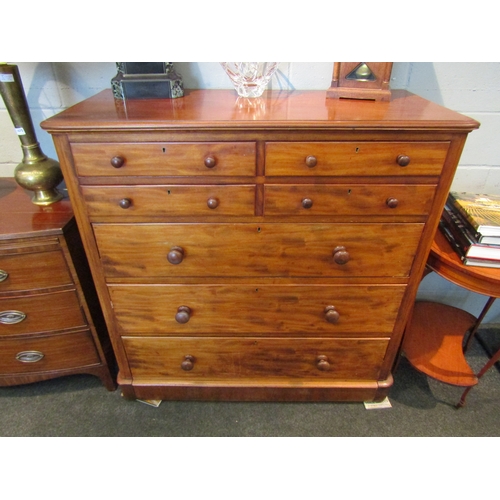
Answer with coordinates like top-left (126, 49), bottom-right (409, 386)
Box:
top-left (403, 230), bottom-right (500, 407)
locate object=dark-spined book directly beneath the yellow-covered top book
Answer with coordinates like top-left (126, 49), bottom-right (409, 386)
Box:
top-left (439, 205), bottom-right (500, 263)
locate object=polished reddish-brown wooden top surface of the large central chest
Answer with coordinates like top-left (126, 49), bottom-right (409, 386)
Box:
top-left (41, 90), bottom-right (478, 132)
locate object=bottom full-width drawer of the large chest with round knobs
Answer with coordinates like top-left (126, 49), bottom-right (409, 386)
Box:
top-left (122, 337), bottom-right (388, 383)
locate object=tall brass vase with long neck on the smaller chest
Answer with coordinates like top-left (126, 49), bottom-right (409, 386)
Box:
top-left (0, 63), bottom-right (63, 205)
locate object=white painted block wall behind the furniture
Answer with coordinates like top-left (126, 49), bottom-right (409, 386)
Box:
top-left (0, 62), bottom-right (500, 323)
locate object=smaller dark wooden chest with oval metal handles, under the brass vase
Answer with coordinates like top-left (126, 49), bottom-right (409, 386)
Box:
top-left (0, 178), bottom-right (116, 391)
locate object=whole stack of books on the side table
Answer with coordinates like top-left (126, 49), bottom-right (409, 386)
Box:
top-left (439, 191), bottom-right (500, 268)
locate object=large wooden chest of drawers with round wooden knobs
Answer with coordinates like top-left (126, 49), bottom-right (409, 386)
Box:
top-left (42, 90), bottom-right (478, 401)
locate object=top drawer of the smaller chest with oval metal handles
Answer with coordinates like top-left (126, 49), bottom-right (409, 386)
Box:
top-left (0, 250), bottom-right (73, 295)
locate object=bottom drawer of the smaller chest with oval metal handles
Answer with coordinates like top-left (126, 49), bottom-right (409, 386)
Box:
top-left (0, 330), bottom-right (100, 375)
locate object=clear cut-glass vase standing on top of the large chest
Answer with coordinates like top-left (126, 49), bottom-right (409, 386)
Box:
top-left (221, 62), bottom-right (279, 97)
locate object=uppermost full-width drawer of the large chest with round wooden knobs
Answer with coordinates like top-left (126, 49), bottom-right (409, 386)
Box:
top-left (93, 223), bottom-right (423, 279)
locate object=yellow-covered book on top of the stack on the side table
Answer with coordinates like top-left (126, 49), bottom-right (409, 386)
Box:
top-left (447, 191), bottom-right (500, 239)
